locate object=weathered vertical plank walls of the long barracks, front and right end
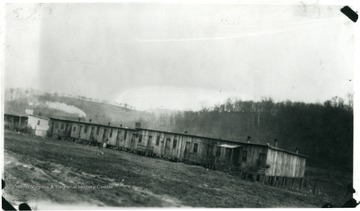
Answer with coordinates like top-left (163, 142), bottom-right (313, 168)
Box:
top-left (50, 120), bottom-right (306, 178)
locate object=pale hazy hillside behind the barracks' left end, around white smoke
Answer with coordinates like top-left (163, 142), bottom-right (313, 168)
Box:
top-left (5, 89), bottom-right (155, 127)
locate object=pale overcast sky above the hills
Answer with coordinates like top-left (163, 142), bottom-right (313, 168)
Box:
top-left (4, 3), bottom-right (354, 109)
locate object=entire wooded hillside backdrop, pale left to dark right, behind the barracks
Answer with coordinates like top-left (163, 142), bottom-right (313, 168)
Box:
top-left (5, 90), bottom-right (353, 170)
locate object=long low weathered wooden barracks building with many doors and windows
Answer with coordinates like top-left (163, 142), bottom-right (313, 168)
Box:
top-left (48, 115), bottom-right (306, 187)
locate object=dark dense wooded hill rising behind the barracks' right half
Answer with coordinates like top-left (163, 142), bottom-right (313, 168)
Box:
top-left (152, 94), bottom-right (353, 170)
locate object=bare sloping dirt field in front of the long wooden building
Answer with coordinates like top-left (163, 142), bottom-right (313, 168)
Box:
top-left (4, 132), bottom-right (325, 209)
